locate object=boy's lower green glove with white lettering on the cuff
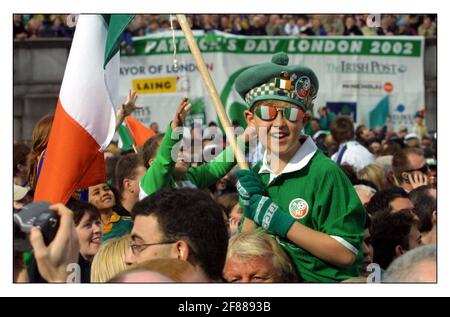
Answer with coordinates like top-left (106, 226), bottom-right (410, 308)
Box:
top-left (248, 195), bottom-right (295, 238)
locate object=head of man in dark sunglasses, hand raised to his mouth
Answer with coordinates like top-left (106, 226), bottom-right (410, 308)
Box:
top-left (392, 147), bottom-right (430, 193)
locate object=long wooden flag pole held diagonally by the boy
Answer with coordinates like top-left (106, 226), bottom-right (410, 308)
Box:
top-left (176, 14), bottom-right (256, 232)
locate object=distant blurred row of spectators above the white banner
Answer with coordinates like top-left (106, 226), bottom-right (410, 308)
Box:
top-left (14, 14), bottom-right (437, 39)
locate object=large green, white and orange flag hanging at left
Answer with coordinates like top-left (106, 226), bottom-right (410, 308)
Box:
top-left (34, 14), bottom-right (133, 203)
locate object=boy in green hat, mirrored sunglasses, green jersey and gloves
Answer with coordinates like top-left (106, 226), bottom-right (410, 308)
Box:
top-left (236, 53), bottom-right (365, 282)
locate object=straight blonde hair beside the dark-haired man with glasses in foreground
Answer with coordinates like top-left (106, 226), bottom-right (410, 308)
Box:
top-left (91, 235), bottom-right (131, 283)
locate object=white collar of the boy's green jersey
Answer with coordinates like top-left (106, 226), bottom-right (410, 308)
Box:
top-left (258, 136), bottom-right (317, 184)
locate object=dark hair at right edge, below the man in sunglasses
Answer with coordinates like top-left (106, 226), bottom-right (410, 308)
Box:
top-left (409, 185), bottom-right (437, 232)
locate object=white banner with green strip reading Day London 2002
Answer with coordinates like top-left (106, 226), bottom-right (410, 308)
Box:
top-left (120, 31), bottom-right (425, 131)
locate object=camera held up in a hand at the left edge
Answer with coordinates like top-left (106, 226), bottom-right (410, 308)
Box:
top-left (14, 202), bottom-right (59, 251)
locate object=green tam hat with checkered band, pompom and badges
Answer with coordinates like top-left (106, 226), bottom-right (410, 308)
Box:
top-left (235, 52), bottom-right (319, 111)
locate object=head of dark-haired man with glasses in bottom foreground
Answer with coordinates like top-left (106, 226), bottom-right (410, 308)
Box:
top-left (125, 188), bottom-right (228, 281)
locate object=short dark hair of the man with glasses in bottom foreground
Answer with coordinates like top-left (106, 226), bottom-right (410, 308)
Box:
top-left (131, 188), bottom-right (228, 281)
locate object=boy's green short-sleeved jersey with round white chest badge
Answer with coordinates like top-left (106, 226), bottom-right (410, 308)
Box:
top-left (244, 138), bottom-right (365, 282)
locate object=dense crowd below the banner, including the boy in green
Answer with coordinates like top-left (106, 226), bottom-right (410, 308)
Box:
top-left (13, 53), bottom-right (437, 283)
